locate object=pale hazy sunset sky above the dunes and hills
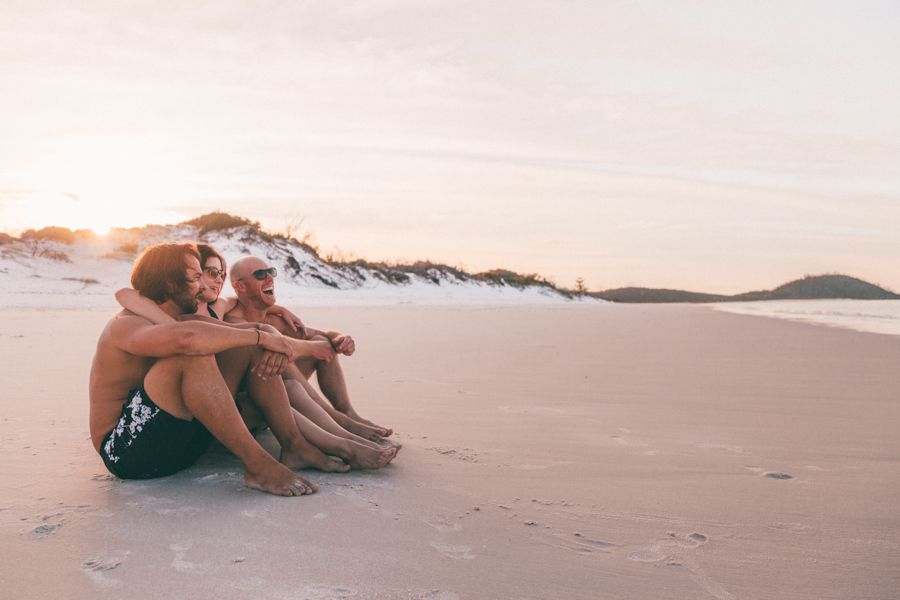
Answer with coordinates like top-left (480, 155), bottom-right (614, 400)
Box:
top-left (0, 0), bottom-right (900, 293)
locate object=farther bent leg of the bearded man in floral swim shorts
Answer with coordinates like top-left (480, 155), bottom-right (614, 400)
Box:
top-left (216, 348), bottom-right (348, 472)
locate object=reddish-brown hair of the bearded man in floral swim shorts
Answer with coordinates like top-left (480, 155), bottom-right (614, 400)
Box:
top-left (131, 243), bottom-right (200, 304)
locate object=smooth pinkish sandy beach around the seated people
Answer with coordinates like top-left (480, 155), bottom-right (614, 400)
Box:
top-left (0, 305), bottom-right (900, 600)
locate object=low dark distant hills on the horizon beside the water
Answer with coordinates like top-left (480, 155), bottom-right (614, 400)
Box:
top-left (590, 275), bottom-right (900, 303)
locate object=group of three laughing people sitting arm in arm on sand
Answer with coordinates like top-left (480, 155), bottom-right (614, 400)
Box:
top-left (90, 244), bottom-right (399, 496)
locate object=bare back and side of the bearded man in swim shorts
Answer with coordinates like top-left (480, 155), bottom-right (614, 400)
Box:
top-left (89, 311), bottom-right (156, 450)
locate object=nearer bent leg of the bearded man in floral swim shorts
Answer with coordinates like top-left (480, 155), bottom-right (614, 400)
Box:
top-left (144, 356), bottom-right (318, 496)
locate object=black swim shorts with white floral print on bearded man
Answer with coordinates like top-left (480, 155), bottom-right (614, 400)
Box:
top-left (100, 386), bottom-right (213, 479)
